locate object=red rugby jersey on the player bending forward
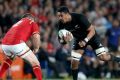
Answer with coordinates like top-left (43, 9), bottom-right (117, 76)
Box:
top-left (2, 18), bottom-right (39, 45)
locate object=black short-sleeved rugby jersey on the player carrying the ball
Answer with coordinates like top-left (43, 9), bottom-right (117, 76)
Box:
top-left (58, 13), bottom-right (91, 39)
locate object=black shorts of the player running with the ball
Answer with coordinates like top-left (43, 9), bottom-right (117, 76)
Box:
top-left (73, 35), bottom-right (103, 50)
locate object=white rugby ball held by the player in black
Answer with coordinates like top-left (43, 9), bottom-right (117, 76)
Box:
top-left (58, 29), bottom-right (73, 41)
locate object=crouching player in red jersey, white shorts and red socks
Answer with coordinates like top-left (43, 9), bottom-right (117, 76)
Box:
top-left (0, 13), bottom-right (42, 80)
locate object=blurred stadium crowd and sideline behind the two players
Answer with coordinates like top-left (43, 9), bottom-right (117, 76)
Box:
top-left (0, 0), bottom-right (120, 80)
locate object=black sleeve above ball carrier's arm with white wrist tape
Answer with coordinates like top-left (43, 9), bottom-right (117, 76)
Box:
top-left (77, 14), bottom-right (91, 30)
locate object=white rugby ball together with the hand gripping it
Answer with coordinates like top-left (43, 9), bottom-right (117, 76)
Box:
top-left (58, 29), bottom-right (73, 43)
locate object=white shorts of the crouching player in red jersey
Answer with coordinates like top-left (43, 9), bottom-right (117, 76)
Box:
top-left (2, 42), bottom-right (33, 58)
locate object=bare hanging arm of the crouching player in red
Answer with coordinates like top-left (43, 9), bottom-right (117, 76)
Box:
top-left (32, 34), bottom-right (41, 53)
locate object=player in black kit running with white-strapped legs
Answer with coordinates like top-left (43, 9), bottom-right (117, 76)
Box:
top-left (57, 6), bottom-right (120, 80)
